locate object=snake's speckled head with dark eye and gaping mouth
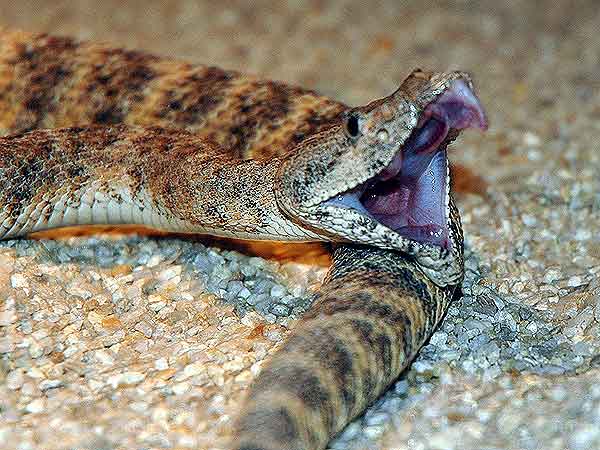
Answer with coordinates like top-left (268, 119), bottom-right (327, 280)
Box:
top-left (276, 70), bottom-right (487, 286)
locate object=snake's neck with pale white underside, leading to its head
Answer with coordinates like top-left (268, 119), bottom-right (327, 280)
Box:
top-left (0, 125), bottom-right (319, 241)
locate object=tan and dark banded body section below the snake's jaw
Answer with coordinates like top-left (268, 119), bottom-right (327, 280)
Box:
top-left (233, 246), bottom-right (454, 450)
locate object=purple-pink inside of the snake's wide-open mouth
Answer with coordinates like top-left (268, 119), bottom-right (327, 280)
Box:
top-left (329, 80), bottom-right (487, 247)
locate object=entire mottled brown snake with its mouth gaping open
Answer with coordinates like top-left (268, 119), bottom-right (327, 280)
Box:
top-left (0, 30), bottom-right (486, 450)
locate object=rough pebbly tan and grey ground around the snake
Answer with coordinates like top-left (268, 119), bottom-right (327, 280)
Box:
top-left (0, 0), bottom-right (600, 450)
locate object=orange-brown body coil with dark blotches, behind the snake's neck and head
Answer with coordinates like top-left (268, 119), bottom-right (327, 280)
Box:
top-left (0, 30), bottom-right (345, 159)
